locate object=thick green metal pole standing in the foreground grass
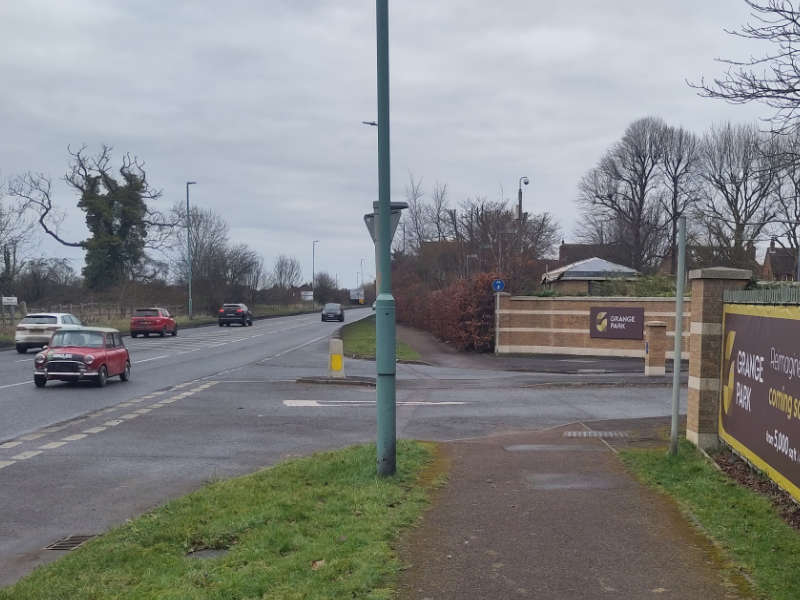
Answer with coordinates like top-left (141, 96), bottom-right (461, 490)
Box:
top-left (375, 0), bottom-right (397, 475)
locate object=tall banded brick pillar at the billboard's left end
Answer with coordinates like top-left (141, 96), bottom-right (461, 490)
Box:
top-left (675, 267), bottom-right (752, 449)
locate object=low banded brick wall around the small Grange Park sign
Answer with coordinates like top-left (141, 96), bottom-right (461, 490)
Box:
top-left (495, 294), bottom-right (690, 359)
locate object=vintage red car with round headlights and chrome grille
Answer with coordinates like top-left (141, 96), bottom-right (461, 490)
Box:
top-left (33, 327), bottom-right (131, 387)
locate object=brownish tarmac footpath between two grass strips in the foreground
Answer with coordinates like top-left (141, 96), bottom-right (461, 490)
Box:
top-left (399, 419), bottom-right (752, 600)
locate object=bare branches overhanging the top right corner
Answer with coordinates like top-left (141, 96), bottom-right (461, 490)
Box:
top-left (692, 0), bottom-right (800, 133)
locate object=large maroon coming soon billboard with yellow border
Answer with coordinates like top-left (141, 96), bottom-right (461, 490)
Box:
top-left (719, 305), bottom-right (800, 500)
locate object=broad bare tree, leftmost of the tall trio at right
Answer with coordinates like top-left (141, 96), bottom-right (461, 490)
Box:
top-left (578, 117), bottom-right (665, 270)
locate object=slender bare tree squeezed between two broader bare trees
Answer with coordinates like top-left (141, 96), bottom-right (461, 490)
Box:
top-left (661, 126), bottom-right (700, 273)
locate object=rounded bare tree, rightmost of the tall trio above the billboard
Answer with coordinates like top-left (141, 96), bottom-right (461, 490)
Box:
top-left (696, 123), bottom-right (780, 267)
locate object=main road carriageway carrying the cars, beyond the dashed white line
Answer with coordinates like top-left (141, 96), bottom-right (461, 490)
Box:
top-left (0, 309), bottom-right (372, 442)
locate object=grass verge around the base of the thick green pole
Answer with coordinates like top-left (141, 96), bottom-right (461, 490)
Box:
top-left (0, 441), bottom-right (441, 600)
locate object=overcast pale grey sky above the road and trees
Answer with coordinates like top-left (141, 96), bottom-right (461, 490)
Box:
top-left (0, 0), bottom-right (769, 286)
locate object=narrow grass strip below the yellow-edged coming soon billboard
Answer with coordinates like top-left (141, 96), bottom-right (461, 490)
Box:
top-left (620, 441), bottom-right (800, 600)
